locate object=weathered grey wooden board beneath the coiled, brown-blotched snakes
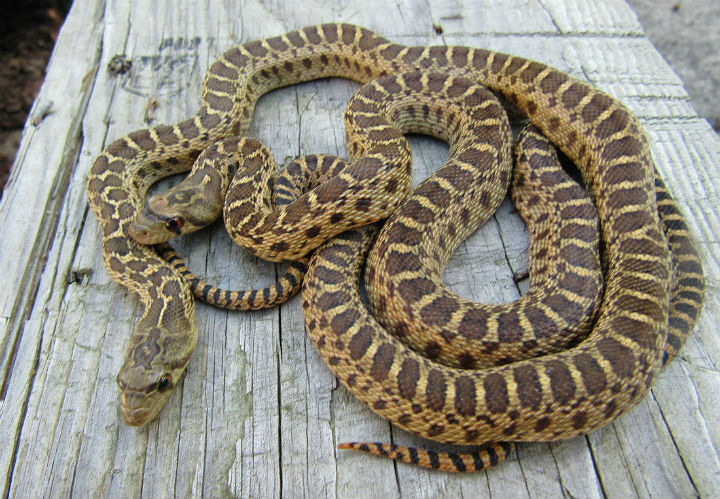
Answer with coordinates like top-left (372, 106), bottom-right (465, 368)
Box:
top-left (0, 0), bottom-right (720, 498)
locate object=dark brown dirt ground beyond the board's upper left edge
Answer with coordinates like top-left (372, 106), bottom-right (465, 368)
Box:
top-left (0, 2), bottom-right (65, 195)
